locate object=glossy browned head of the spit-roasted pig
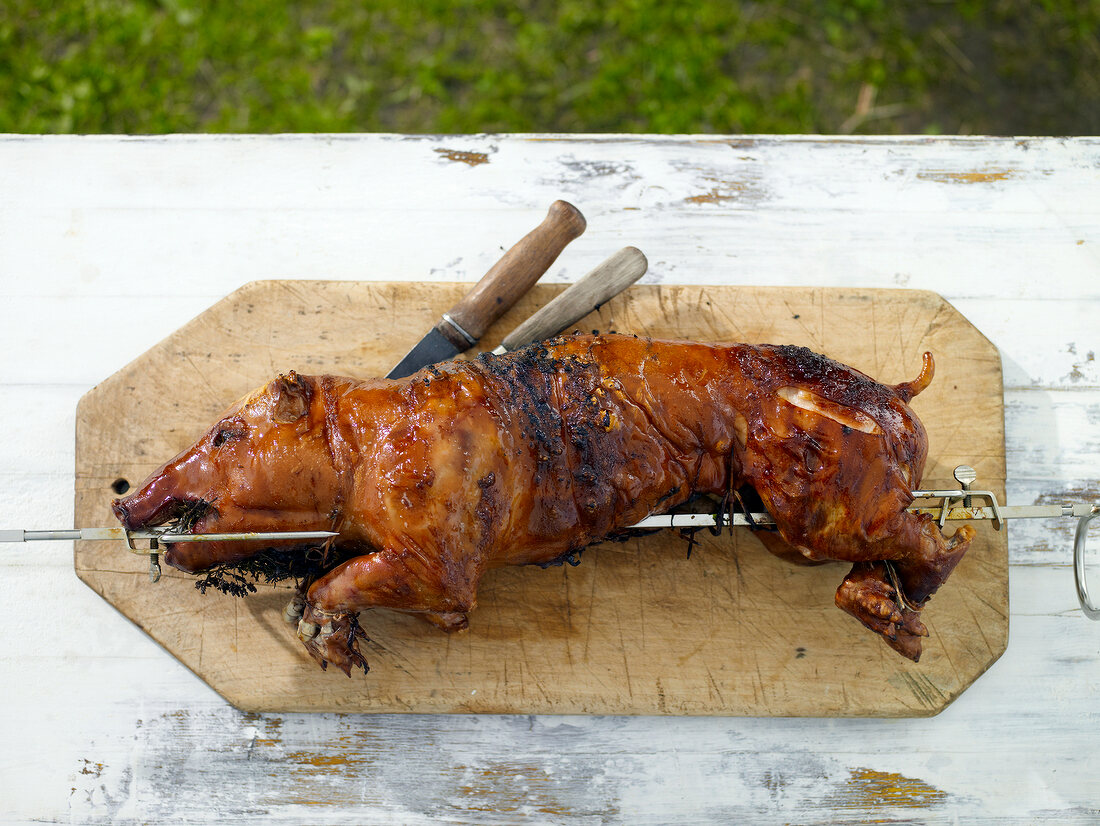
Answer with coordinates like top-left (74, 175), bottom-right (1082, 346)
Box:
top-left (112, 372), bottom-right (339, 573)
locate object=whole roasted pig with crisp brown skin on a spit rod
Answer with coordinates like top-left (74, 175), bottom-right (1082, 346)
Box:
top-left (114, 335), bottom-right (972, 671)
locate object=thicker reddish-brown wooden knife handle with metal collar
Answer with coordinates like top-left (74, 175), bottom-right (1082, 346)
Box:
top-left (436, 201), bottom-right (586, 351)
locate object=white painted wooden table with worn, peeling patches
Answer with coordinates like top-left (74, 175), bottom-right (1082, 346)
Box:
top-left (0, 136), bottom-right (1100, 824)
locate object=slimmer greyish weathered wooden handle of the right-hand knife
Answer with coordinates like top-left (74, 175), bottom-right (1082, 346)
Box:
top-left (502, 246), bottom-right (649, 350)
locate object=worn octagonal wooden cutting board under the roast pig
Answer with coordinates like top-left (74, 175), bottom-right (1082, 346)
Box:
top-left (75, 282), bottom-right (1008, 716)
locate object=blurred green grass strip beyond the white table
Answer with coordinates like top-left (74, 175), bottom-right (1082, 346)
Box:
top-left (0, 0), bottom-right (1100, 134)
